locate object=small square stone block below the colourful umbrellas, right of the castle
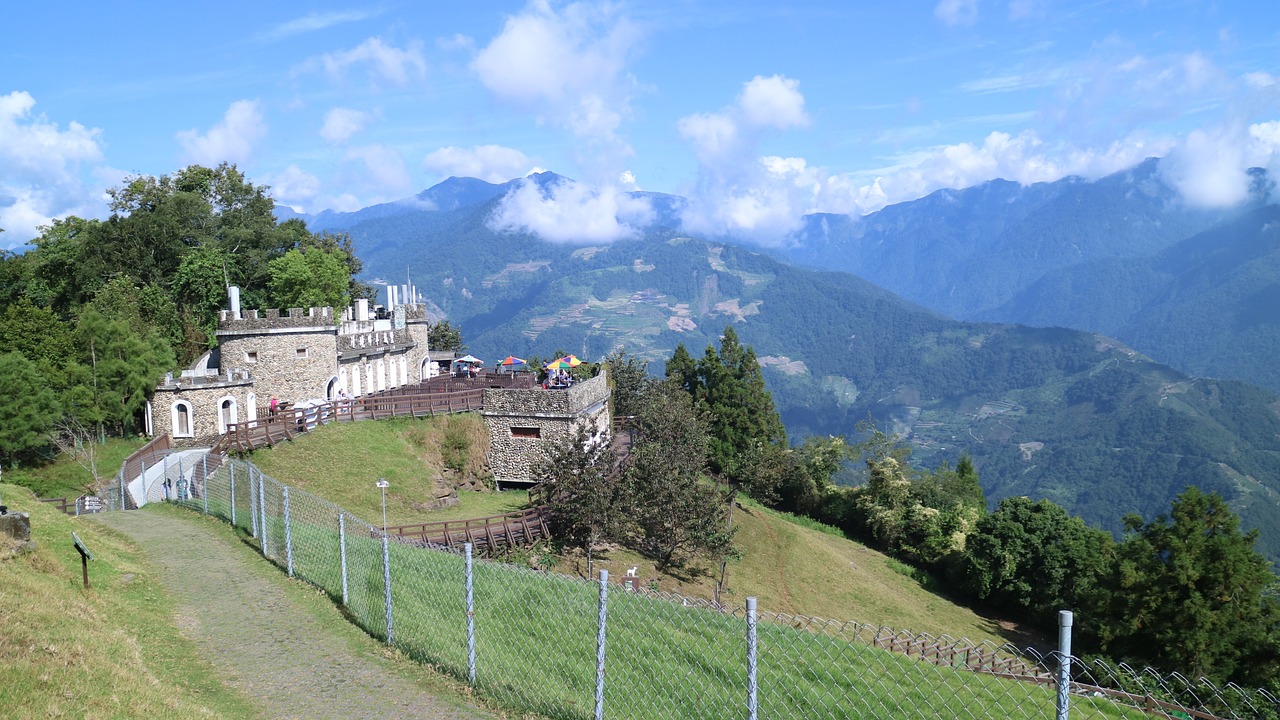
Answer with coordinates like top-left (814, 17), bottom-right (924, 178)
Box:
top-left (480, 373), bottom-right (611, 487)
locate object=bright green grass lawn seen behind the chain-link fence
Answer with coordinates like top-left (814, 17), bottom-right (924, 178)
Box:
top-left (177, 468), bottom-right (1142, 719)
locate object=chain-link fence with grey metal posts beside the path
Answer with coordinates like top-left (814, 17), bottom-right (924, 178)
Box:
top-left (113, 456), bottom-right (1280, 720)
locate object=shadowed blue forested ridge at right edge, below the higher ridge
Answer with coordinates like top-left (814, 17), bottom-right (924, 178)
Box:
top-left (991, 205), bottom-right (1280, 391)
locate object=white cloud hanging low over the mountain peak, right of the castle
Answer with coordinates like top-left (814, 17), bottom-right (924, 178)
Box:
top-left (489, 178), bottom-right (653, 243)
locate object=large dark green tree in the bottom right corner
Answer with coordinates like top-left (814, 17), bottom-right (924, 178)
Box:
top-left (1097, 487), bottom-right (1280, 688)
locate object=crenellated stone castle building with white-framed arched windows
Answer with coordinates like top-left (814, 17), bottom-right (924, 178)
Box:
top-left (146, 288), bottom-right (436, 443)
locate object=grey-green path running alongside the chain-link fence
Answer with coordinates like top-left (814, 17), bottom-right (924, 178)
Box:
top-left (97, 511), bottom-right (493, 720)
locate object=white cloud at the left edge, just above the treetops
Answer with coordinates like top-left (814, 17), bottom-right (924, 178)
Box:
top-left (0, 91), bottom-right (104, 247)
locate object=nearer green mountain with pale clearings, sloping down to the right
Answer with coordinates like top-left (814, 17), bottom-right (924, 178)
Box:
top-left (280, 178), bottom-right (1280, 557)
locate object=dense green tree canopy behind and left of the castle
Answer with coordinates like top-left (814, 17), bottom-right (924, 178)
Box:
top-left (0, 163), bottom-right (370, 471)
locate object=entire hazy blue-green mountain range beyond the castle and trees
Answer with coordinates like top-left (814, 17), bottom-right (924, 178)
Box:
top-left (280, 160), bottom-right (1280, 559)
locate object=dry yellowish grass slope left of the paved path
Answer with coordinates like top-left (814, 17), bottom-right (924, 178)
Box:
top-left (0, 486), bottom-right (255, 717)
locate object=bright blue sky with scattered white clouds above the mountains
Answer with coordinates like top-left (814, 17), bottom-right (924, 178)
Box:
top-left (0, 0), bottom-right (1280, 247)
